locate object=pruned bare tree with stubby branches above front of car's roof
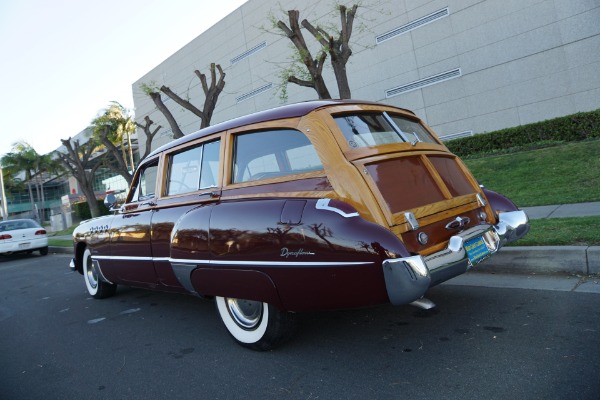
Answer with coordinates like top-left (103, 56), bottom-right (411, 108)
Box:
top-left (142, 63), bottom-right (225, 139)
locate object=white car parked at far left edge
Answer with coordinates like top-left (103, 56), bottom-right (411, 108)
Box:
top-left (0, 219), bottom-right (48, 256)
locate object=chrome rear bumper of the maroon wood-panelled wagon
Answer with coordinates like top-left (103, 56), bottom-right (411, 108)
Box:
top-left (383, 211), bottom-right (529, 305)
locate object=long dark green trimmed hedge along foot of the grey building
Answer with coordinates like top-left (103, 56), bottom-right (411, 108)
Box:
top-left (445, 109), bottom-right (600, 157)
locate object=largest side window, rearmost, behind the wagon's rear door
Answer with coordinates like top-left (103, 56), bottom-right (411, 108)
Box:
top-left (232, 129), bottom-right (323, 183)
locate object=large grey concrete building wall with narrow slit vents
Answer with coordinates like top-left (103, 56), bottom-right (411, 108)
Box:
top-left (133, 0), bottom-right (600, 148)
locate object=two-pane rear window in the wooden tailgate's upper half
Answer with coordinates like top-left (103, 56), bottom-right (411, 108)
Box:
top-left (334, 112), bottom-right (437, 148)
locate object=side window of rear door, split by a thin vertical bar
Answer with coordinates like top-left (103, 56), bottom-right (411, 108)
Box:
top-left (167, 140), bottom-right (221, 196)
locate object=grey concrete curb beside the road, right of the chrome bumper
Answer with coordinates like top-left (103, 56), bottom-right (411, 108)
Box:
top-left (480, 246), bottom-right (600, 275)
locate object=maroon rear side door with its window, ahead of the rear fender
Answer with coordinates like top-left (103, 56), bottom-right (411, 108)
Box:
top-left (151, 135), bottom-right (223, 291)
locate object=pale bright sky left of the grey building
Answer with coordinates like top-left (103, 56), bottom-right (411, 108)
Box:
top-left (0, 0), bottom-right (246, 157)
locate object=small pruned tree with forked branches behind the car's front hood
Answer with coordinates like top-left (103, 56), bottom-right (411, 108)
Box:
top-left (56, 138), bottom-right (102, 218)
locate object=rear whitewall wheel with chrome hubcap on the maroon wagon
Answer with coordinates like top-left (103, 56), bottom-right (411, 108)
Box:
top-left (215, 297), bottom-right (295, 351)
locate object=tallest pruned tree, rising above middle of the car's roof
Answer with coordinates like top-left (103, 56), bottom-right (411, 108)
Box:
top-left (276, 4), bottom-right (359, 99)
